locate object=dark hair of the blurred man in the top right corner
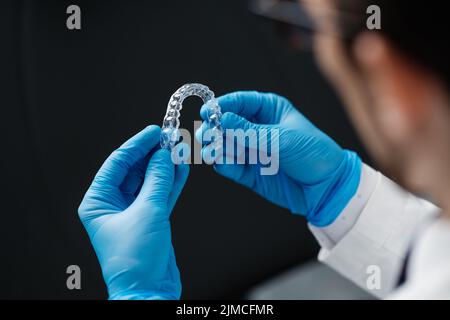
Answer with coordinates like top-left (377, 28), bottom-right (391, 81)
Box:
top-left (337, 0), bottom-right (450, 88)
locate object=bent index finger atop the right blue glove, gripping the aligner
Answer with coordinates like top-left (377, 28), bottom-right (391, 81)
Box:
top-left (200, 91), bottom-right (291, 124)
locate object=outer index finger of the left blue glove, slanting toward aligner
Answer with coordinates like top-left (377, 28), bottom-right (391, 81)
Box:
top-left (91, 125), bottom-right (161, 189)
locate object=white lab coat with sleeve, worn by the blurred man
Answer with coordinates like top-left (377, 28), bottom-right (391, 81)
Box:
top-left (310, 165), bottom-right (444, 299)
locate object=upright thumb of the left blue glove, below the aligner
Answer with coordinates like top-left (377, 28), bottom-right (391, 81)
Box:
top-left (136, 149), bottom-right (175, 208)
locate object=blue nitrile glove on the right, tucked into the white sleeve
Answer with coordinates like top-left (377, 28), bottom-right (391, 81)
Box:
top-left (196, 92), bottom-right (362, 227)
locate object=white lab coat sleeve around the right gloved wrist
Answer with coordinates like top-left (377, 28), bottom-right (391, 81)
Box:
top-left (310, 165), bottom-right (439, 298)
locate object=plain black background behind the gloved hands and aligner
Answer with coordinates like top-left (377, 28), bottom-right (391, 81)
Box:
top-left (0, 0), bottom-right (367, 299)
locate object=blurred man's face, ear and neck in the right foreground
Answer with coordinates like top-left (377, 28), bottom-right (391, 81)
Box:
top-left (300, 0), bottom-right (450, 202)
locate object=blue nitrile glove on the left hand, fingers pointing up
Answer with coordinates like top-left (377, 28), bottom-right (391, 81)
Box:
top-left (78, 126), bottom-right (189, 299)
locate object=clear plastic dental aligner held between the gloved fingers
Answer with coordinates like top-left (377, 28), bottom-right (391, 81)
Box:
top-left (160, 83), bottom-right (222, 149)
